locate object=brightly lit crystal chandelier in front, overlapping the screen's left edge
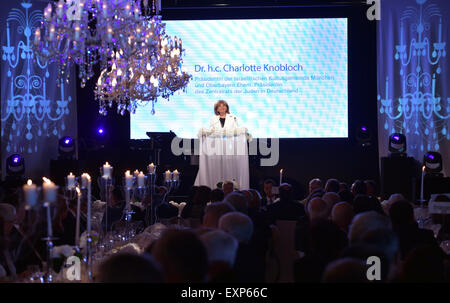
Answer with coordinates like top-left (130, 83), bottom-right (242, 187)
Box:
top-left (95, 16), bottom-right (191, 115)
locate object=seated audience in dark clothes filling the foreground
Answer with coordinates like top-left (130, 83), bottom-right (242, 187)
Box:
top-left (0, 178), bottom-right (450, 283)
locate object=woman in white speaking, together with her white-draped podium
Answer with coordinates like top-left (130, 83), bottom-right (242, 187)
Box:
top-left (194, 100), bottom-right (249, 189)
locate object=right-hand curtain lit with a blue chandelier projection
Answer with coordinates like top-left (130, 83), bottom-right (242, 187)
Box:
top-left (377, 0), bottom-right (450, 176)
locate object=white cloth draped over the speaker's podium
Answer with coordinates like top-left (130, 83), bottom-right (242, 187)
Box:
top-left (194, 134), bottom-right (250, 189)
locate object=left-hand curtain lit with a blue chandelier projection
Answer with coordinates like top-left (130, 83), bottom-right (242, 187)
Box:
top-left (0, 0), bottom-right (77, 179)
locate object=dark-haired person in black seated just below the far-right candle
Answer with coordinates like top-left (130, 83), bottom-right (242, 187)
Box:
top-left (389, 200), bottom-right (438, 259)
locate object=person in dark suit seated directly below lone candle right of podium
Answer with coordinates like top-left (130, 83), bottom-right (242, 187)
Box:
top-left (267, 183), bottom-right (305, 222)
